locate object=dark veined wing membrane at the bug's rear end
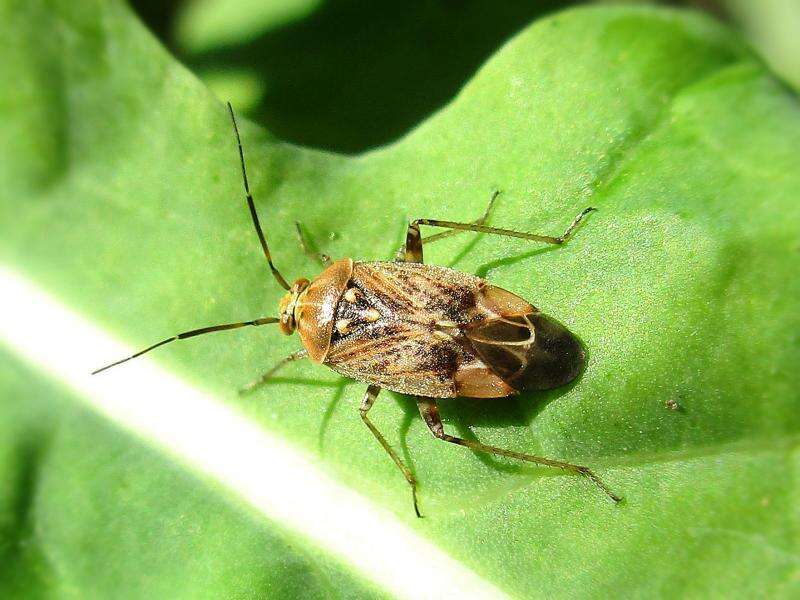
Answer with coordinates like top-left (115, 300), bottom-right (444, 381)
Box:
top-left (465, 312), bottom-right (585, 391)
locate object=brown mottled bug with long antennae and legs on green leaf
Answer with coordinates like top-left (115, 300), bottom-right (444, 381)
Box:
top-left (94, 103), bottom-right (621, 516)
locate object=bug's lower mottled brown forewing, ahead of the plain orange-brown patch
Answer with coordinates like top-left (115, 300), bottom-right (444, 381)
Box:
top-left (325, 319), bottom-right (462, 398)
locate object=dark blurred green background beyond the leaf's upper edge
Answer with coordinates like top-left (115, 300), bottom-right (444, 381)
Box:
top-left (132, 0), bottom-right (800, 153)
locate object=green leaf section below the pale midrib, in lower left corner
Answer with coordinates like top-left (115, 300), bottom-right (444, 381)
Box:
top-left (0, 351), bottom-right (388, 598)
